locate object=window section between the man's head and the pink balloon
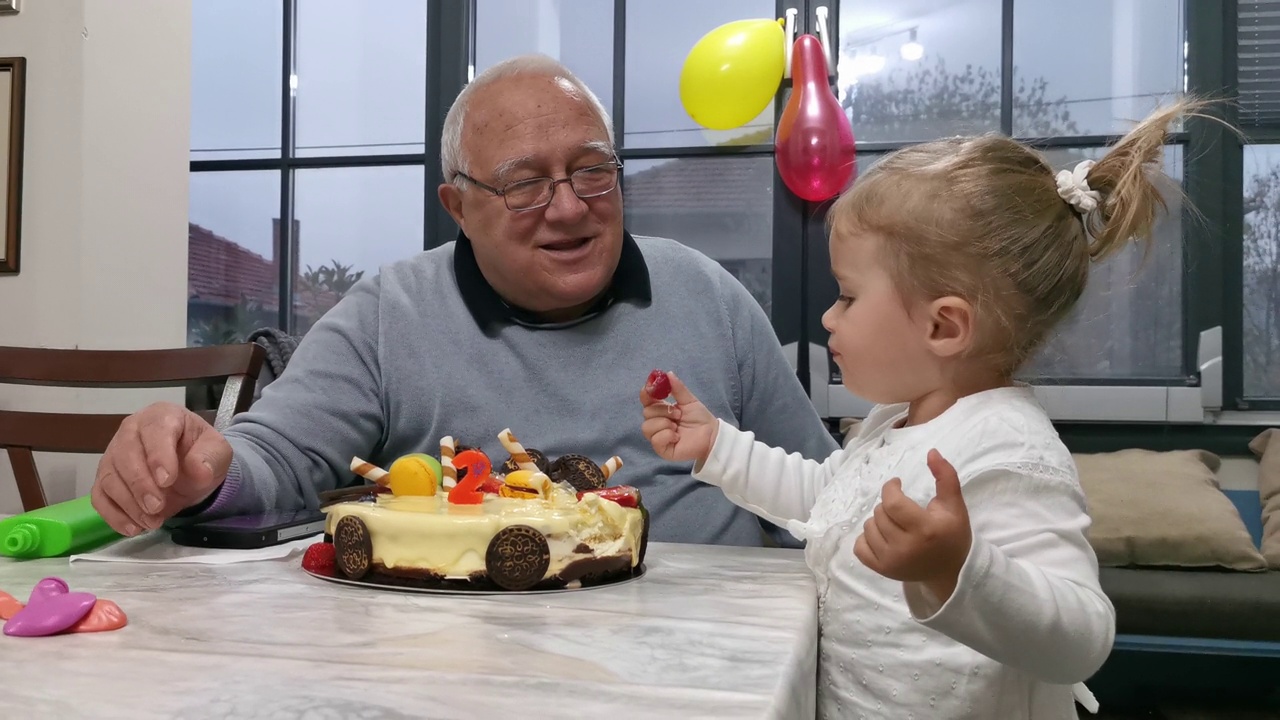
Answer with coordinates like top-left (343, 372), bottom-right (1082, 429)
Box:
top-left (622, 0), bottom-right (777, 320)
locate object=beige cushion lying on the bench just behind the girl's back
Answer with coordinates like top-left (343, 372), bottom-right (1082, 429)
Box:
top-left (1075, 450), bottom-right (1267, 570)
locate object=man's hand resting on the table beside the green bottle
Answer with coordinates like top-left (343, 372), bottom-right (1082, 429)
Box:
top-left (90, 402), bottom-right (232, 537)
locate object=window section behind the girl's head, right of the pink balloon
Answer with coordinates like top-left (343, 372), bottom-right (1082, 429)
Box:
top-left (806, 0), bottom-right (1213, 420)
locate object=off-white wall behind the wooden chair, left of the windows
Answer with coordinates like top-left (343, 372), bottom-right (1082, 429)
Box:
top-left (0, 0), bottom-right (191, 512)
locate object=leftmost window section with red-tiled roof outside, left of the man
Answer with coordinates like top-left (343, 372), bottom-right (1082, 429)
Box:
top-left (187, 0), bottom-right (429, 345)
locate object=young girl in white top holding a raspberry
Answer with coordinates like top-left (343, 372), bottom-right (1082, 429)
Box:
top-left (640, 105), bottom-right (1203, 720)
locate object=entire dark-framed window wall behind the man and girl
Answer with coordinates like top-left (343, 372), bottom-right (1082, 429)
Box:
top-left (188, 0), bottom-right (1280, 421)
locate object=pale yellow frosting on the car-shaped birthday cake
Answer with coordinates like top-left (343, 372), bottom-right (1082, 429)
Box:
top-left (326, 484), bottom-right (644, 578)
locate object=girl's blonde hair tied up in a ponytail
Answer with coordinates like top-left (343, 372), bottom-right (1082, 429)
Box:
top-left (827, 100), bottom-right (1202, 374)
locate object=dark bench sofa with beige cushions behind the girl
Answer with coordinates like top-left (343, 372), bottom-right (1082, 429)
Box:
top-left (1075, 429), bottom-right (1280, 710)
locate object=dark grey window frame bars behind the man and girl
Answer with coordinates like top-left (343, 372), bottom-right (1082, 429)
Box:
top-left (191, 0), bottom-right (1280, 427)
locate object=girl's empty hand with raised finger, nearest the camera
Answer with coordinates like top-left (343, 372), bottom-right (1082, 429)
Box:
top-left (854, 450), bottom-right (973, 602)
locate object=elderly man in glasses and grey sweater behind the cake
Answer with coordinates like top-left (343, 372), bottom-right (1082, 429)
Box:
top-left (92, 56), bottom-right (836, 544)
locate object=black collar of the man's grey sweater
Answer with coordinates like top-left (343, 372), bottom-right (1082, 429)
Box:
top-left (453, 231), bottom-right (653, 337)
